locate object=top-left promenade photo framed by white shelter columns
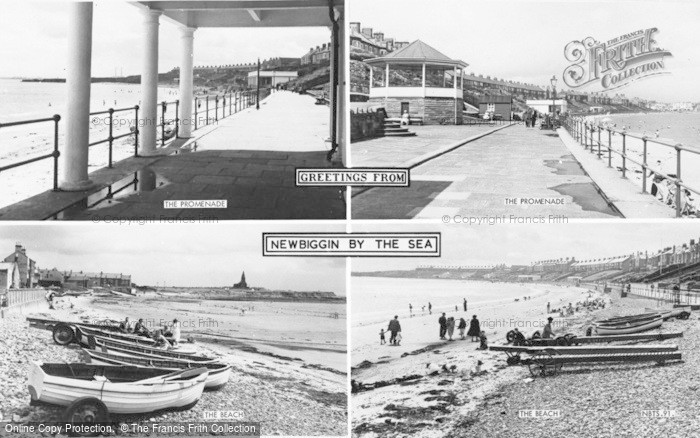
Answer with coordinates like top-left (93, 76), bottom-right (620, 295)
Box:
top-left (0, 0), bottom-right (348, 222)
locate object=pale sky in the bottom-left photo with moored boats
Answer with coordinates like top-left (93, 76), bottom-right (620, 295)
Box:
top-left (0, 222), bottom-right (345, 295)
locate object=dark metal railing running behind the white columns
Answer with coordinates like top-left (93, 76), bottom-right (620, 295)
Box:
top-left (0, 88), bottom-right (271, 191)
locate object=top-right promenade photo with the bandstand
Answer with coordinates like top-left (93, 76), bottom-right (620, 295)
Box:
top-left (348, 0), bottom-right (700, 221)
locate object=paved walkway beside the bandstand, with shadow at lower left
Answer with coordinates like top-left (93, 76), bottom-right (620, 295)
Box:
top-left (352, 125), bottom-right (619, 221)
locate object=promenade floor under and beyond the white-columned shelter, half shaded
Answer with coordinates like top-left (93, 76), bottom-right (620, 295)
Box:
top-left (0, 92), bottom-right (345, 222)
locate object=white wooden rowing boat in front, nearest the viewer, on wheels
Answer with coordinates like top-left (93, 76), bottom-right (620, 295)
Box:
top-left (29, 361), bottom-right (209, 419)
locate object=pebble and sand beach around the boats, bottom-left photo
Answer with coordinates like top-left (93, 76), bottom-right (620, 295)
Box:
top-left (0, 296), bottom-right (347, 436)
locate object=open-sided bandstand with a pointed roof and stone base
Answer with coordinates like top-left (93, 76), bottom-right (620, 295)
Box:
top-left (365, 40), bottom-right (468, 125)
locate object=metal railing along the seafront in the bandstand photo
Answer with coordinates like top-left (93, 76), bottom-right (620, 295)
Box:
top-left (562, 117), bottom-right (700, 217)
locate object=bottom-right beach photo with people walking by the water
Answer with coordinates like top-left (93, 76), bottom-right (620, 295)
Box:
top-left (350, 223), bottom-right (700, 438)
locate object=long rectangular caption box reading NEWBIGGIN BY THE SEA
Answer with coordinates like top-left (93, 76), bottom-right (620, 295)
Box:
top-left (263, 233), bottom-right (441, 257)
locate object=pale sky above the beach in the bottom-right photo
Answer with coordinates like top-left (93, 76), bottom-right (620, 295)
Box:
top-left (351, 220), bottom-right (700, 272)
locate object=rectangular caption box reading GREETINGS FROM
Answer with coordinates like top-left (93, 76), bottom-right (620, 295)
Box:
top-left (296, 167), bottom-right (411, 187)
